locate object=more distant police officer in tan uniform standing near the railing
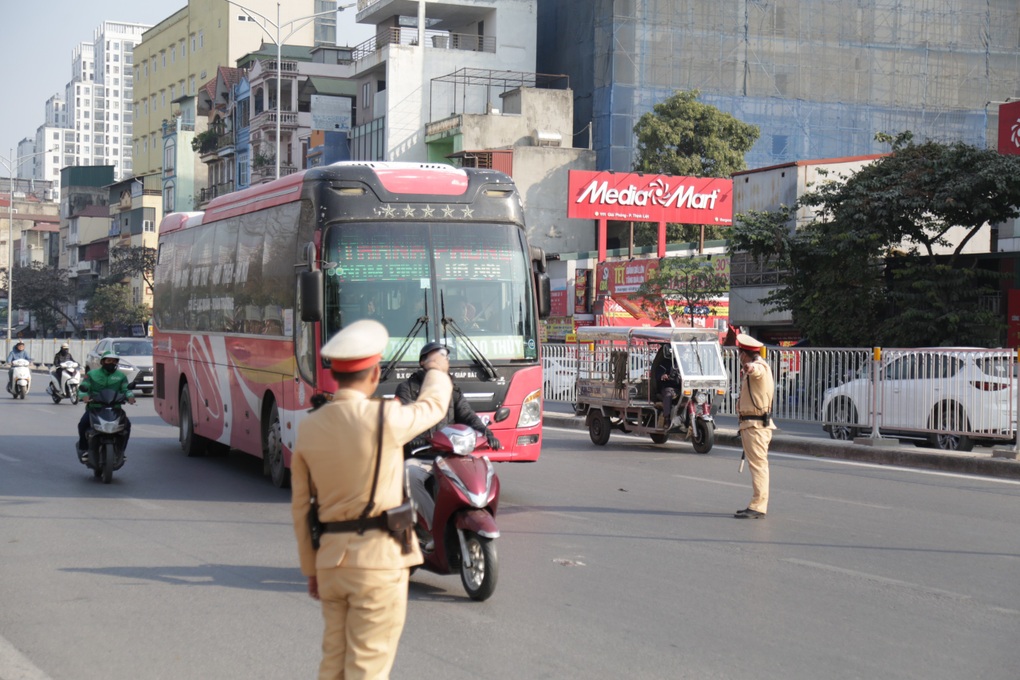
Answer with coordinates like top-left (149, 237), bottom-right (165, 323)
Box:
top-left (733, 333), bottom-right (775, 519)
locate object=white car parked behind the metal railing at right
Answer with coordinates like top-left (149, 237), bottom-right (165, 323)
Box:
top-left (822, 349), bottom-right (1017, 451)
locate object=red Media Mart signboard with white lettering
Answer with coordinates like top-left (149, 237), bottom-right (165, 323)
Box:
top-left (567, 170), bottom-right (733, 224)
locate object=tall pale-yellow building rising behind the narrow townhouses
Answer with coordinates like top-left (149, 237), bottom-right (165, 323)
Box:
top-left (132, 0), bottom-right (337, 182)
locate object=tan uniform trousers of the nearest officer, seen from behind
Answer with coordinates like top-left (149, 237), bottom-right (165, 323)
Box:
top-left (317, 567), bottom-right (410, 680)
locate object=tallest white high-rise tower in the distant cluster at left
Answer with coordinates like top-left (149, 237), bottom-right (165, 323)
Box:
top-left (63, 21), bottom-right (148, 178)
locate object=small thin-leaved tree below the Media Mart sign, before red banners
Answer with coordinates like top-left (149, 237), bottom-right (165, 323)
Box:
top-left (638, 257), bottom-right (729, 327)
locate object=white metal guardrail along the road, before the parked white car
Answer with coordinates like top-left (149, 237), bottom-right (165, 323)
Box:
top-left (543, 344), bottom-right (1020, 449)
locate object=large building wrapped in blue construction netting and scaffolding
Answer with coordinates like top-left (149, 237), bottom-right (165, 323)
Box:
top-left (538, 0), bottom-right (1020, 171)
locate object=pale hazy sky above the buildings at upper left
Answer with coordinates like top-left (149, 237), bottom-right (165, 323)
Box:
top-left (0, 0), bottom-right (371, 170)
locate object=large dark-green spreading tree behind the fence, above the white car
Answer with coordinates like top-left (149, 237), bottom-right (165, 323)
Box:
top-left (730, 133), bottom-right (1020, 347)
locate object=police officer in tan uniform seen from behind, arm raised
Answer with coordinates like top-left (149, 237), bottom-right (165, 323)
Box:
top-left (291, 319), bottom-right (453, 680)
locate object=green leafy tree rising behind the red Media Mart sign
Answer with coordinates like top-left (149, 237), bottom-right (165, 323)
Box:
top-left (633, 90), bottom-right (760, 245)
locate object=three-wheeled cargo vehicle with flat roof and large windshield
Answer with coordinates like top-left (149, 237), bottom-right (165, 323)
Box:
top-left (574, 326), bottom-right (729, 454)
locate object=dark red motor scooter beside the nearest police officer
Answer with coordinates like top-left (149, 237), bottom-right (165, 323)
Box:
top-left (414, 424), bottom-right (500, 601)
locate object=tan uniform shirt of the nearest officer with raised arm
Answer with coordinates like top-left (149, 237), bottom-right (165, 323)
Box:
top-left (291, 370), bottom-right (453, 576)
